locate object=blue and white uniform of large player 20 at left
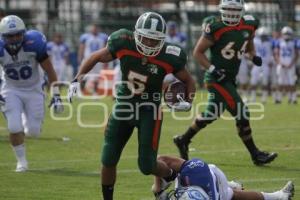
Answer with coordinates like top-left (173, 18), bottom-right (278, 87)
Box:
top-left (0, 30), bottom-right (48, 135)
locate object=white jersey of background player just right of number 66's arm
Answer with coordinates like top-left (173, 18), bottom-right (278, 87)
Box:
top-left (253, 37), bottom-right (274, 67)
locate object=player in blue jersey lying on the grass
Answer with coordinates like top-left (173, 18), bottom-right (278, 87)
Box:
top-left (152, 156), bottom-right (295, 200)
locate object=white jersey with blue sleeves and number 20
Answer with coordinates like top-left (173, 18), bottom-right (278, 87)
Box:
top-left (0, 30), bottom-right (48, 90)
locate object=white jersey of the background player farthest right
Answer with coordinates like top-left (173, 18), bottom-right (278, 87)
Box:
top-left (275, 39), bottom-right (299, 66)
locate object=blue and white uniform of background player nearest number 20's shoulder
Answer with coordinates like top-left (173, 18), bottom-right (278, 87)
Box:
top-left (47, 41), bottom-right (69, 81)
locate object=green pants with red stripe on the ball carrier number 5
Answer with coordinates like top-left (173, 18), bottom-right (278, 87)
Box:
top-left (102, 104), bottom-right (162, 175)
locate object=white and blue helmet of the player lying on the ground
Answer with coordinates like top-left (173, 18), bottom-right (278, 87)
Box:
top-left (175, 186), bottom-right (209, 200)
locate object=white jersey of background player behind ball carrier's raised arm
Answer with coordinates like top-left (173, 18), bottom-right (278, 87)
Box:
top-left (79, 33), bottom-right (108, 59)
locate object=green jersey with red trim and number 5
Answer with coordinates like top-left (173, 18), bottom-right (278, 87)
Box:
top-left (108, 29), bottom-right (187, 104)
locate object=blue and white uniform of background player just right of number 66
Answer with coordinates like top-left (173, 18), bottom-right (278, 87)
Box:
top-left (250, 37), bottom-right (276, 86)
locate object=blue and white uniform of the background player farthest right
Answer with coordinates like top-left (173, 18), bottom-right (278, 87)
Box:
top-left (274, 39), bottom-right (300, 86)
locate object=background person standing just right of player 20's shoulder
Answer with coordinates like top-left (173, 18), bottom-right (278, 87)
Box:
top-left (47, 33), bottom-right (72, 84)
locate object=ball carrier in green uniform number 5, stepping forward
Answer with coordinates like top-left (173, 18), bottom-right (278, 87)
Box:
top-left (68, 12), bottom-right (195, 200)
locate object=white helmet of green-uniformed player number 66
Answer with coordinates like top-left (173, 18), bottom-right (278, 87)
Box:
top-left (219, 0), bottom-right (244, 26)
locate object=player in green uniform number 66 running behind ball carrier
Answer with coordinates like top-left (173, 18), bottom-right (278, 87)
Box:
top-left (173, 0), bottom-right (277, 165)
